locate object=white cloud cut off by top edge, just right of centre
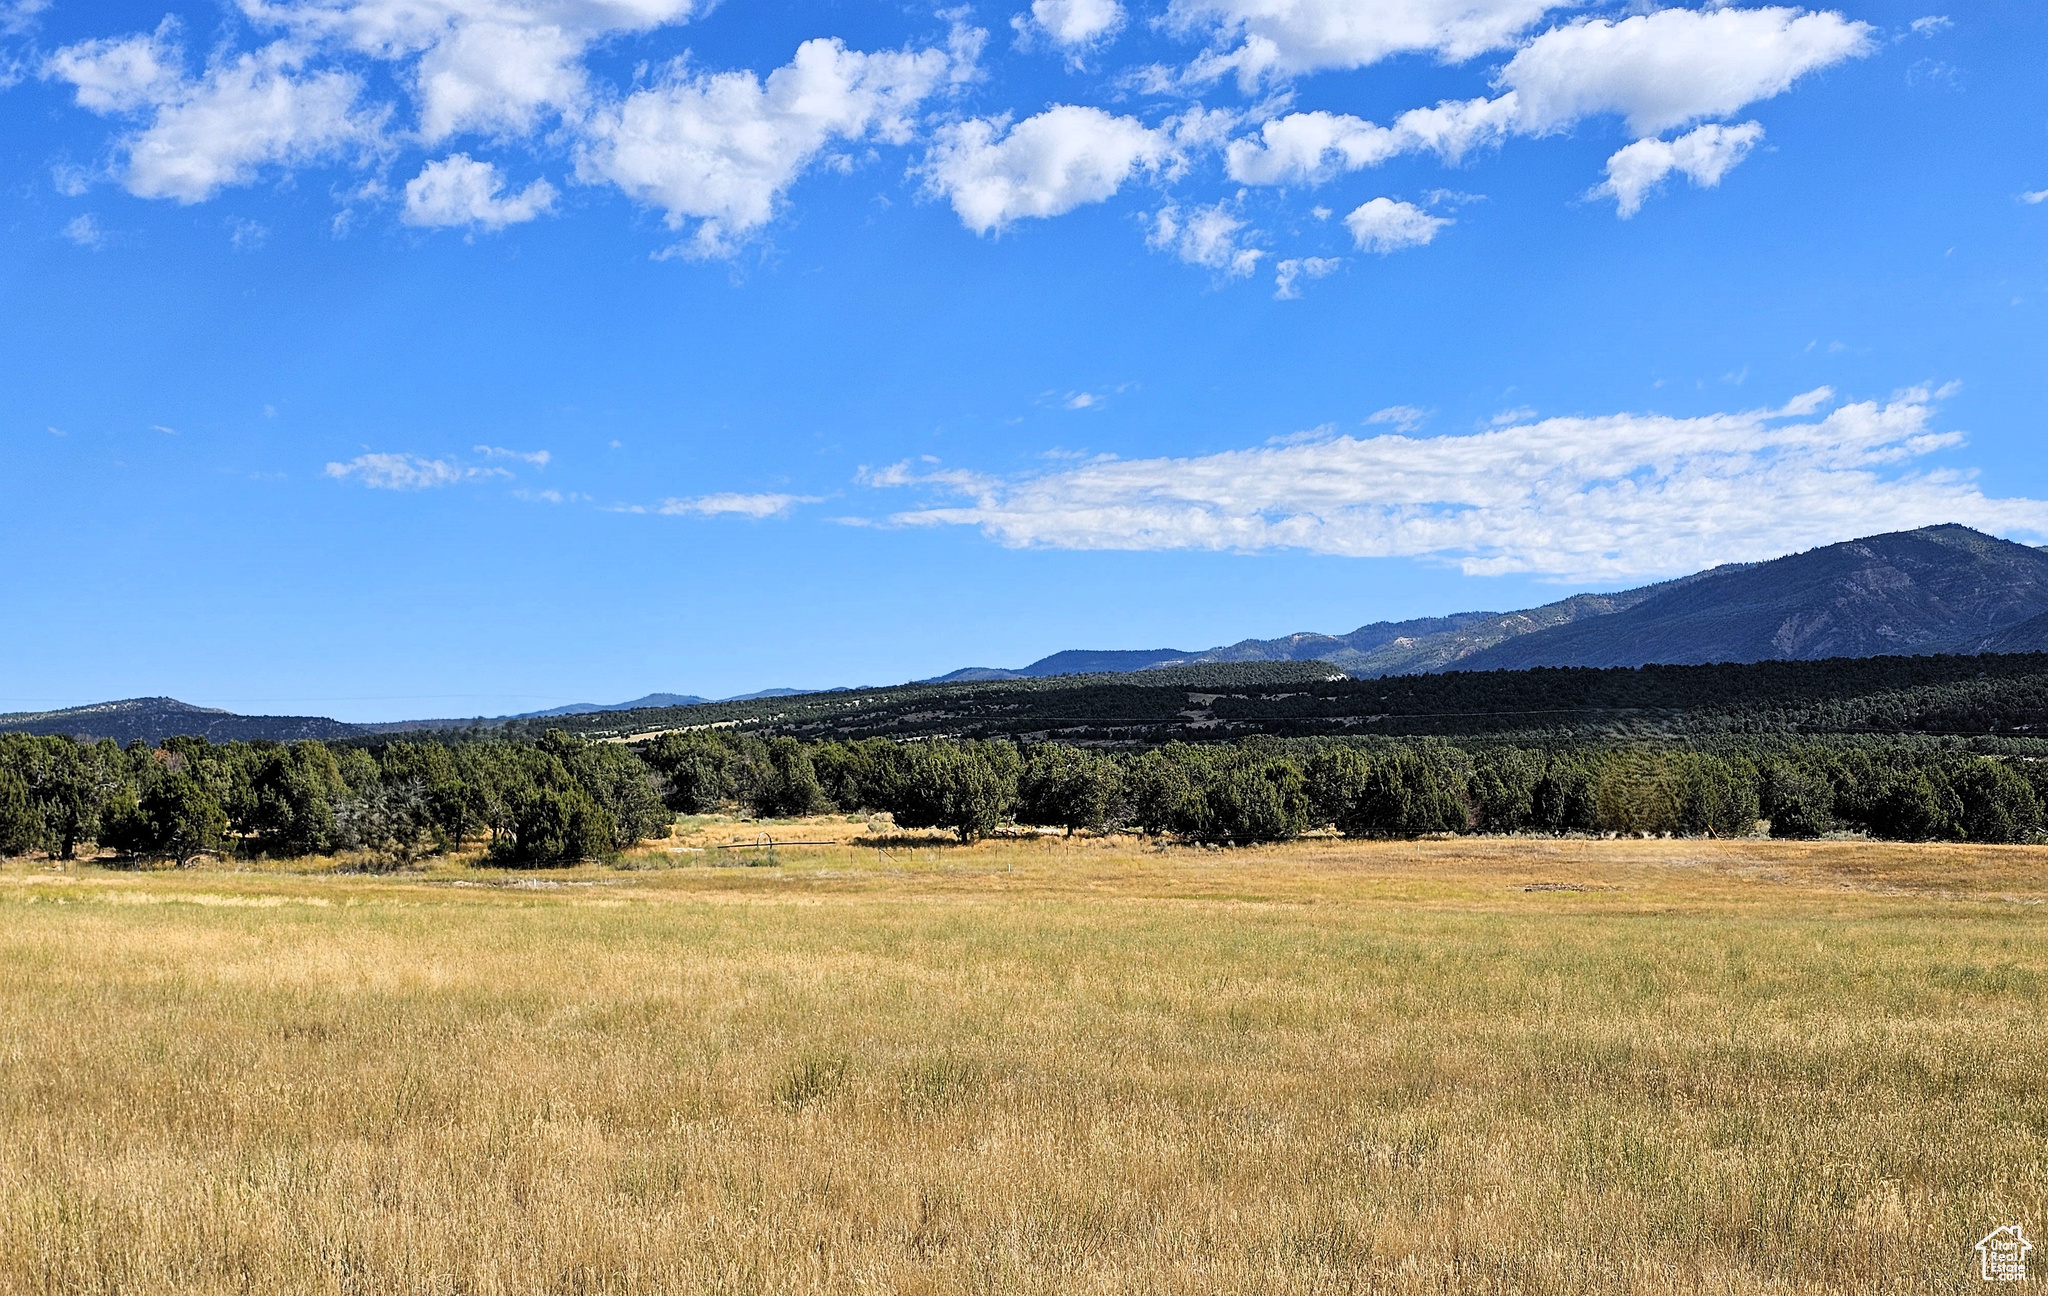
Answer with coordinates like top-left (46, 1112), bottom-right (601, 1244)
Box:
top-left (1167, 0), bottom-right (1559, 90)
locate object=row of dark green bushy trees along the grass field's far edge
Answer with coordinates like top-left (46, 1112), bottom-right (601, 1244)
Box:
top-left (0, 729), bottom-right (2048, 868)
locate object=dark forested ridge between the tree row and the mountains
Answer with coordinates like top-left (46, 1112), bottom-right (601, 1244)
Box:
top-left (508, 653), bottom-right (2048, 743)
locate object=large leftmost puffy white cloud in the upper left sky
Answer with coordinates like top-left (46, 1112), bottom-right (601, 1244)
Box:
top-left (47, 25), bottom-right (383, 203)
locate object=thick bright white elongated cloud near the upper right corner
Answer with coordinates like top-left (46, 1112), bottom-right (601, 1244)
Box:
top-left (1499, 8), bottom-right (1876, 135)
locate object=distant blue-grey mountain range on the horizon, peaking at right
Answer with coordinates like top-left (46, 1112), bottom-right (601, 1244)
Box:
top-left (16, 524), bottom-right (2048, 741)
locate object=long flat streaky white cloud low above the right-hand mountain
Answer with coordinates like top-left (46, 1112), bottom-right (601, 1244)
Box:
top-left (870, 391), bottom-right (2048, 579)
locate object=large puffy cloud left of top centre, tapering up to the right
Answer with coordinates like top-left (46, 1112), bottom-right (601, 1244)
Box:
top-left (578, 33), bottom-right (958, 256)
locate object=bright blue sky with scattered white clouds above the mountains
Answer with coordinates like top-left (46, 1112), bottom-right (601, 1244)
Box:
top-left (0, 0), bottom-right (2048, 719)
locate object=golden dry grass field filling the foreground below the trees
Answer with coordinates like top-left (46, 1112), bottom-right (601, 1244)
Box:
top-left (0, 821), bottom-right (2048, 1296)
